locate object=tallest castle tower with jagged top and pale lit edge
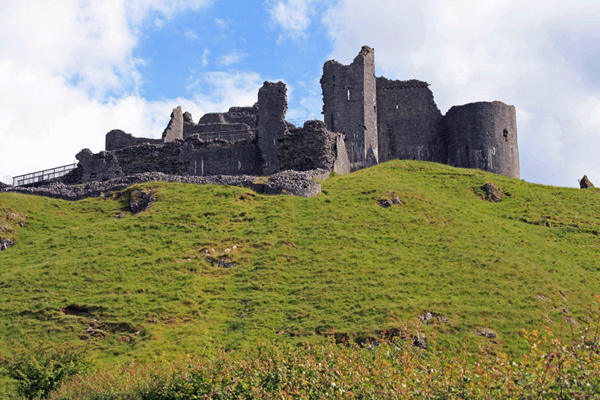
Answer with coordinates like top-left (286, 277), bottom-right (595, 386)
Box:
top-left (321, 46), bottom-right (379, 171)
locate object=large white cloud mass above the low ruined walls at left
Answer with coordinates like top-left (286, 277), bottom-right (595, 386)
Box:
top-left (0, 0), bottom-right (260, 178)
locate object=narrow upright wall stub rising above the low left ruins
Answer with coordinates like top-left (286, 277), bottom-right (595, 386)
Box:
top-left (257, 82), bottom-right (288, 175)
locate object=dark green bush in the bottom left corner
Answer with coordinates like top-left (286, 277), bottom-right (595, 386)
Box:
top-left (0, 344), bottom-right (89, 399)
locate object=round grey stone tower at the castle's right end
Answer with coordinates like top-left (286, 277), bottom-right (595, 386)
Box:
top-left (444, 101), bottom-right (521, 179)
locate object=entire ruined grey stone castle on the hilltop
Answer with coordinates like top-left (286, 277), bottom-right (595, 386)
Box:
top-left (65, 46), bottom-right (520, 183)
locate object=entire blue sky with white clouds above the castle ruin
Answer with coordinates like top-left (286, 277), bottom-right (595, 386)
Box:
top-left (0, 0), bottom-right (600, 187)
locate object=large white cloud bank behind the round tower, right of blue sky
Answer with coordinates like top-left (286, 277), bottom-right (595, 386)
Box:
top-left (323, 0), bottom-right (600, 186)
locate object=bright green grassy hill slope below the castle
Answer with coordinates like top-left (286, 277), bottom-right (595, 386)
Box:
top-left (0, 161), bottom-right (600, 363)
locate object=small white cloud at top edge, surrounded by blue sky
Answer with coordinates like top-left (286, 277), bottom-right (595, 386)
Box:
top-left (266, 0), bottom-right (317, 38)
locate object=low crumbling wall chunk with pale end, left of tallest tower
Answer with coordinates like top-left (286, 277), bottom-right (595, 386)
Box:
top-left (279, 120), bottom-right (350, 174)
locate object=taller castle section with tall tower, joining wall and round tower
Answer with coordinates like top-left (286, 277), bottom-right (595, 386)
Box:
top-left (321, 46), bottom-right (520, 179)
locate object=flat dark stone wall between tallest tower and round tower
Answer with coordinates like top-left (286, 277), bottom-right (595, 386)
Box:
top-left (377, 78), bottom-right (447, 163)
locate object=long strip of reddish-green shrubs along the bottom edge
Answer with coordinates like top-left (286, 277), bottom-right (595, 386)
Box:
top-left (52, 316), bottom-right (600, 400)
